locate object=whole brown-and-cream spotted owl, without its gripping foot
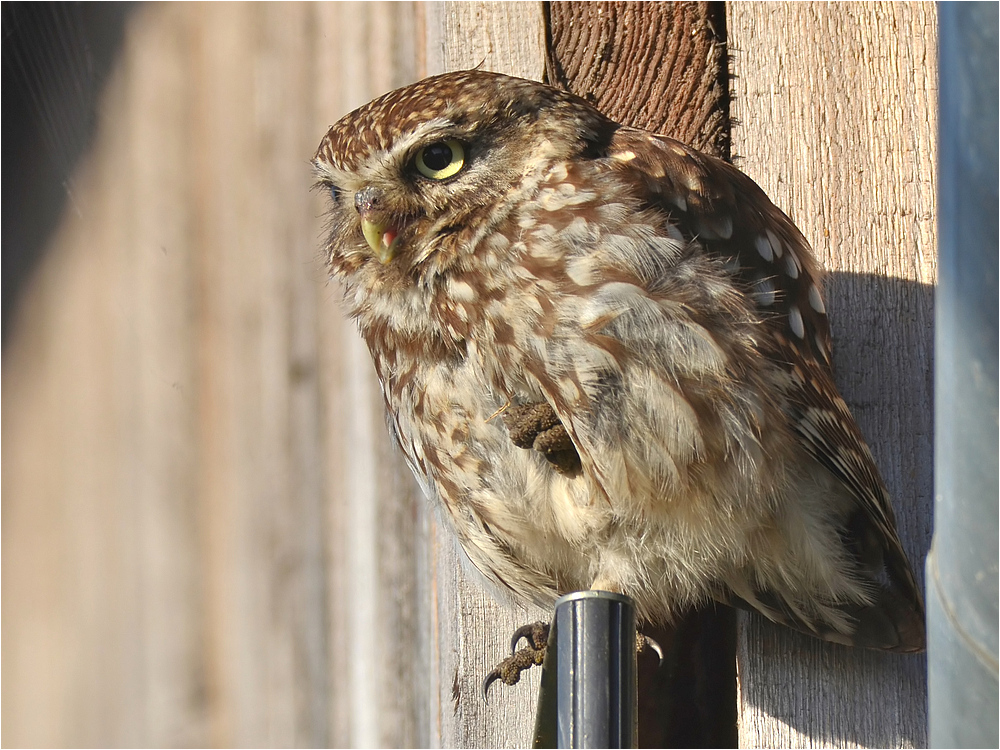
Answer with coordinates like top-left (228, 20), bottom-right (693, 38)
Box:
top-left (315, 71), bottom-right (924, 651)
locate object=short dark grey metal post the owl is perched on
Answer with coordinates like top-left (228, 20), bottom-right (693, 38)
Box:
top-left (535, 591), bottom-right (638, 748)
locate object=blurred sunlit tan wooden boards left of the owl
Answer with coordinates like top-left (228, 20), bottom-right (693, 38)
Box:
top-left (3, 3), bottom-right (429, 746)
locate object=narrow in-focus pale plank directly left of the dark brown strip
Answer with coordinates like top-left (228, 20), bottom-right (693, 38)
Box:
top-left (421, 2), bottom-right (551, 747)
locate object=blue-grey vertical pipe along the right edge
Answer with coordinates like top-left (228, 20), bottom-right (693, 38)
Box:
top-left (927, 3), bottom-right (1000, 747)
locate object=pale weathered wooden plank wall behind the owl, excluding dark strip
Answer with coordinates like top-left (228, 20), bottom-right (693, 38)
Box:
top-left (2, 3), bottom-right (937, 746)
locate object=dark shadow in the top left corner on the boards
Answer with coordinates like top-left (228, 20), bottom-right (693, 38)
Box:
top-left (0, 2), bottom-right (135, 346)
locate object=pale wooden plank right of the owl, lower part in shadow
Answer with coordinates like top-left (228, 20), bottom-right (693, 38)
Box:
top-left (728, 3), bottom-right (937, 747)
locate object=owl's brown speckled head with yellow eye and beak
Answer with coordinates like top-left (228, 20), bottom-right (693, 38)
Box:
top-left (314, 71), bottom-right (616, 277)
